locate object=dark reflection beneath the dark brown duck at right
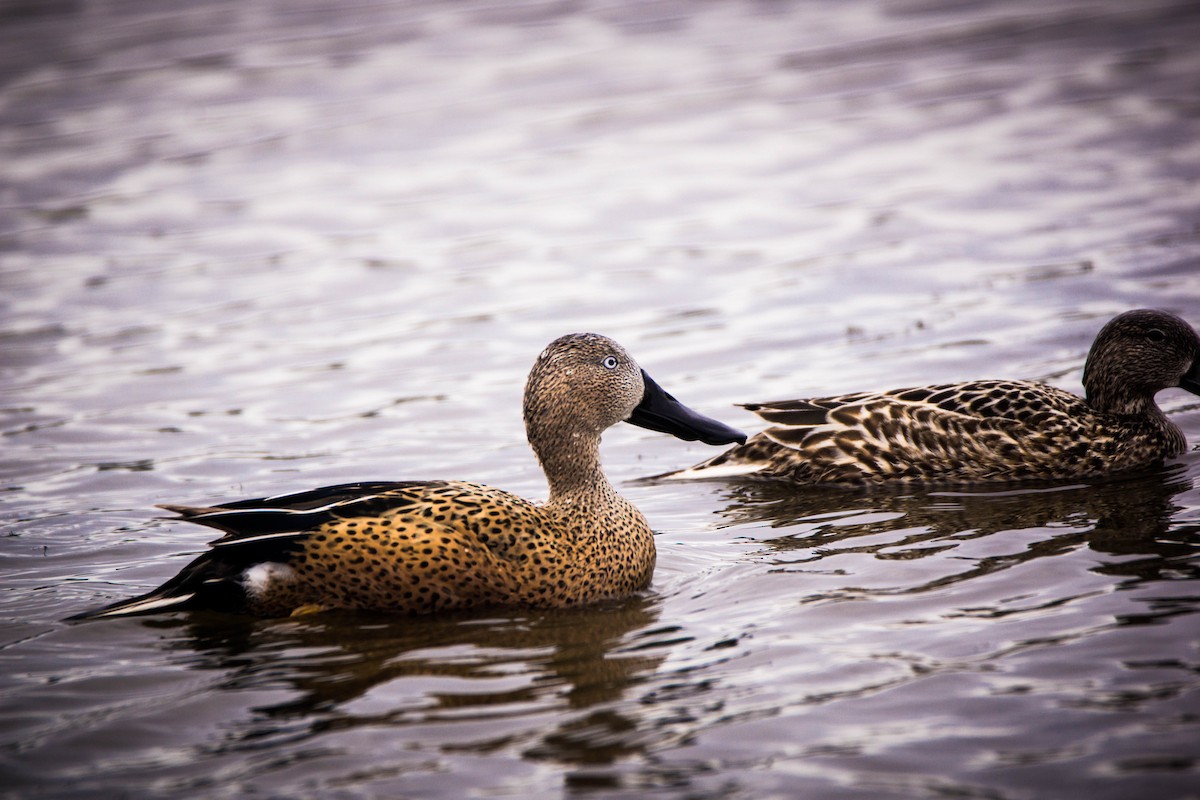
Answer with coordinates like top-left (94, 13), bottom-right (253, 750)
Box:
top-left (705, 464), bottom-right (1200, 593)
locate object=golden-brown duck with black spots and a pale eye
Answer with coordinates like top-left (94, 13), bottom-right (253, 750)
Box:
top-left (68, 333), bottom-right (746, 620)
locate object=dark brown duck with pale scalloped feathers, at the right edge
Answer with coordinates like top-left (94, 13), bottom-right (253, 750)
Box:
top-left (658, 308), bottom-right (1200, 486)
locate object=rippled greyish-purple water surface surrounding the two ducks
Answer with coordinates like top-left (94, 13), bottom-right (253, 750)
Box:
top-left (0, 0), bottom-right (1200, 799)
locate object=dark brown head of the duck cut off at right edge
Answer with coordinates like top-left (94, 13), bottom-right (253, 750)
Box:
top-left (1084, 308), bottom-right (1200, 414)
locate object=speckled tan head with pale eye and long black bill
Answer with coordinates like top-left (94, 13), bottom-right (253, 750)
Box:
top-left (524, 333), bottom-right (746, 445)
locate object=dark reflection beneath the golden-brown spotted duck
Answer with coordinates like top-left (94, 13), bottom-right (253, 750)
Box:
top-left (144, 597), bottom-right (678, 764)
